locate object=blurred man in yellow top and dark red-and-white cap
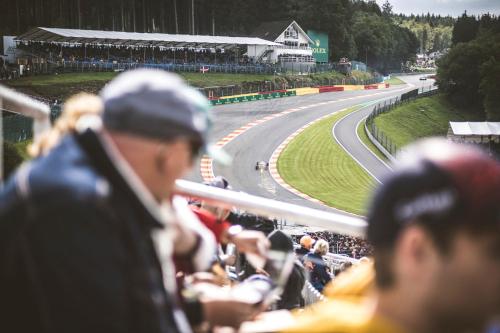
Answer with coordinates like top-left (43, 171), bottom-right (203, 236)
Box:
top-left (286, 139), bottom-right (500, 333)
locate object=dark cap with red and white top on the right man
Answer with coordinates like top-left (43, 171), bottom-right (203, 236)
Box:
top-left (368, 139), bottom-right (500, 247)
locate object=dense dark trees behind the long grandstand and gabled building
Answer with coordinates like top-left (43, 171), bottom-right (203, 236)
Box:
top-left (0, 0), bottom-right (418, 70)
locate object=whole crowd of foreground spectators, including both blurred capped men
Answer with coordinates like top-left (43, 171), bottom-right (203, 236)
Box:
top-left (0, 69), bottom-right (500, 333)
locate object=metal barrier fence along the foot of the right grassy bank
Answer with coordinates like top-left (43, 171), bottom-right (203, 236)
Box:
top-left (365, 86), bottom-right (439, 157)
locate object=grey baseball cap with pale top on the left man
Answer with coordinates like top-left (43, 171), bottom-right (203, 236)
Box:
top-left (100, 69), bottom-right (230, 164)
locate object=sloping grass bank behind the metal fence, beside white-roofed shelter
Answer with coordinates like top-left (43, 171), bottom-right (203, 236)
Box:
top-left (375, 95), bottom-right (484, 147)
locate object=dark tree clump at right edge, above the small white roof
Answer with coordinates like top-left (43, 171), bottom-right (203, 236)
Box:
top-left (438, 13), bottom-right (500, 121)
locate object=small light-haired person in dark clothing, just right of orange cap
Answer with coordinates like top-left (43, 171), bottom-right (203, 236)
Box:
top-left (304, 239), bottom-right (332, 292)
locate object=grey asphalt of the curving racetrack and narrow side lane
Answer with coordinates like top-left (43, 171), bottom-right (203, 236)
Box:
top-left (186, 76), bottom-right (430, 212)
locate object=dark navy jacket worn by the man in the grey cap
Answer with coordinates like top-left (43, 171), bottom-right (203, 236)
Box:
top-left (0, 130), bottom-right (184, 333)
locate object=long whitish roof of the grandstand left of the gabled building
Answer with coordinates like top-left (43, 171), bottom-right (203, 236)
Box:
top-left (15, 27), bottom-right (279, 50)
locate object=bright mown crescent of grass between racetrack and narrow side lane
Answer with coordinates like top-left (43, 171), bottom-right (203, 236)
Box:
top-left (277, 107), bottom-right (374, 215)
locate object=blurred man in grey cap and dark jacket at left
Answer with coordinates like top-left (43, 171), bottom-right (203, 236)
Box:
top-left (0, 70), bottom-right (262, 332)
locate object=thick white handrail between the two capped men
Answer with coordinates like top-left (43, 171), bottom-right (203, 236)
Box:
top-left (176, 180), bottom-right (367, 238)
